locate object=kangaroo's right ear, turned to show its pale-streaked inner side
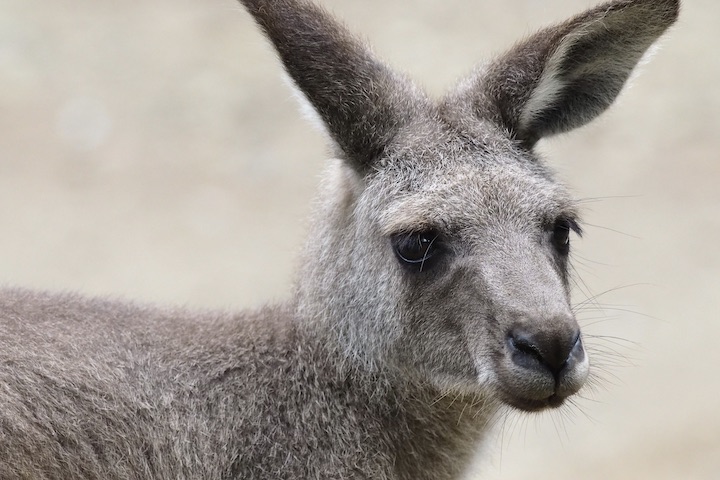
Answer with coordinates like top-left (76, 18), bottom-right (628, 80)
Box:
top-left (452, 0), bottom-right (679, 148)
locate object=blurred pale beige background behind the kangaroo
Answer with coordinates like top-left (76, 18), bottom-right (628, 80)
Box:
top-left (0, 0), bottom-right (720, 480)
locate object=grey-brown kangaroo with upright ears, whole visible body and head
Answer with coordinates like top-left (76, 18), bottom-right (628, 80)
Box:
top-left (0, 0), bottom-right (679, 480)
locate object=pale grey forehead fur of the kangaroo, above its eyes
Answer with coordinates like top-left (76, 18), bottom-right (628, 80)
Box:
top-left (364, 128), bottom-right (577, 235)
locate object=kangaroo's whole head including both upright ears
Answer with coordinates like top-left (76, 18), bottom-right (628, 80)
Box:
top-left (243, 0), bottom-right (678, 410)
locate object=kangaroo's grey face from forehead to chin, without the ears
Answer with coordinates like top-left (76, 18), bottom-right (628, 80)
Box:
top-left (349, 127), bottom-right (588, 410)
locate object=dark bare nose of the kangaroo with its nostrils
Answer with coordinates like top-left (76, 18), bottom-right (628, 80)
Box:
top-left (508, 327), bottom-right (585, 379)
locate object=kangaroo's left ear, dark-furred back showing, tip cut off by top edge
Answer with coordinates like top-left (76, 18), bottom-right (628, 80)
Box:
top-left (241, 0), bottom-right (425, 172)
